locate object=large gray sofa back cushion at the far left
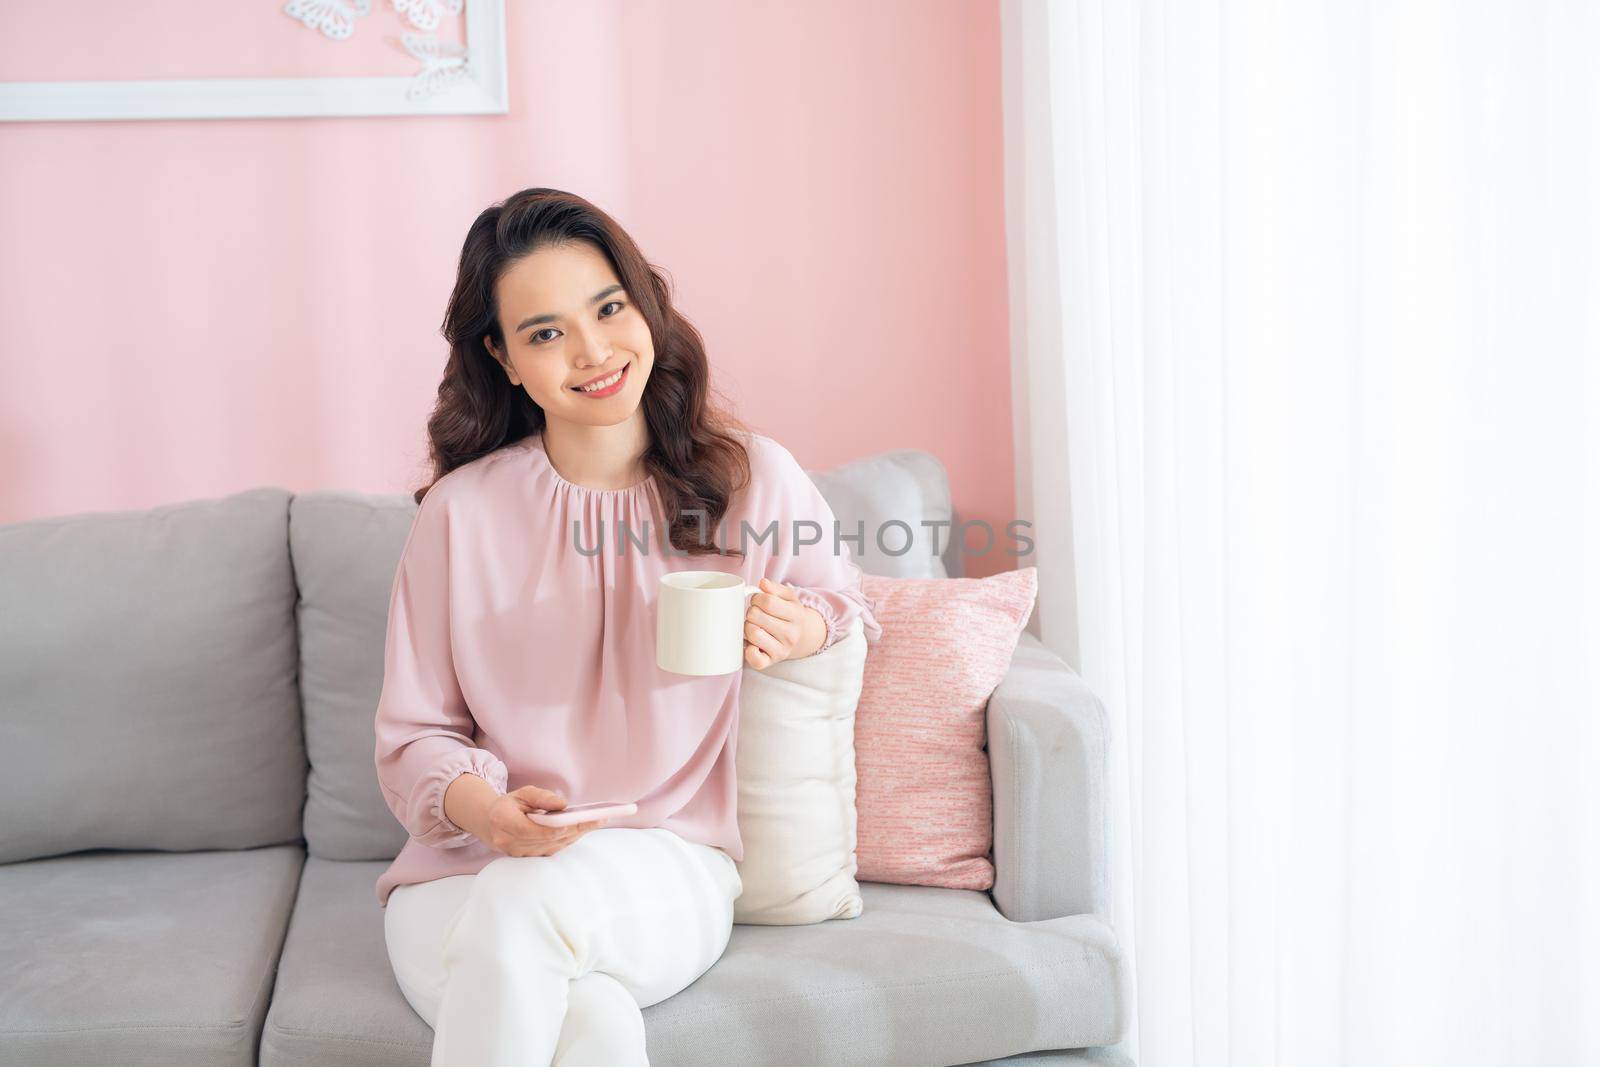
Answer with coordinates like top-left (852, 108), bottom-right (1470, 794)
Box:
top-left (0, 488), bottom-right (306, 862)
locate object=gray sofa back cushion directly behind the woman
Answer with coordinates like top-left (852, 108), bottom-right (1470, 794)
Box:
top-left (290, 450), bottom-right (950, 859)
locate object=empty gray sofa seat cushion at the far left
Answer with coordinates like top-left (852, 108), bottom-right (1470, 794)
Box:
top-left (0, 845), bottom-right (306, 1064)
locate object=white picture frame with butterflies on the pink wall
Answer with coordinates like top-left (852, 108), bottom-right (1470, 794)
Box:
top-left (0, 0), bottom-right (509, 122)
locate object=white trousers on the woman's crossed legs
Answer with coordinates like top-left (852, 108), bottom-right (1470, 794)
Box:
top-left (384, 827), bottom-right (744, 1067)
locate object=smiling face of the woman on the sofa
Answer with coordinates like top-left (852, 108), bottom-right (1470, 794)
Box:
top-left (483, 243), bottom-right (656, 426)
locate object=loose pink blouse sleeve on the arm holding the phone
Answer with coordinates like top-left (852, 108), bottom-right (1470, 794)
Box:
top-left (374, 486), bottom-right (507, 848)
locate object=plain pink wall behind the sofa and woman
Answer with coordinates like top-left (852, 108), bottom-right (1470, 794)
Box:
top-left (0, 0), bottom-right (1014, 574)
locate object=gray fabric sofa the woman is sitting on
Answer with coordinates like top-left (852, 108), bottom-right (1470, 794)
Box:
top-left (0, 450), bottom-right (1128, 1067)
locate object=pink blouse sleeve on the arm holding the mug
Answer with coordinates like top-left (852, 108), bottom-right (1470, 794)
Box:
top-left (752, 442), bottom-right (883, 653)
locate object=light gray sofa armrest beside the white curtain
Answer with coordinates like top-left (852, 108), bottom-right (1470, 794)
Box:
top-left (987, 630), bottom-right (1109, 923)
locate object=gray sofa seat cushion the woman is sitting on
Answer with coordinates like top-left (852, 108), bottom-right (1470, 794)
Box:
top-left (261, 857), bottom-right (1123, 1067)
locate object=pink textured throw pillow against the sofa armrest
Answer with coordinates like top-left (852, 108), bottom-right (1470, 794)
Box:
top-left (856, 566), bottom-right (1038, 889)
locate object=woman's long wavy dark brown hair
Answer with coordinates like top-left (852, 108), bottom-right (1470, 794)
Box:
top-left (413, 189), bottom-right (750, 555)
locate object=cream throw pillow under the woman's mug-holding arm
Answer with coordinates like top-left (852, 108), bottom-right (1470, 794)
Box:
top-left (733, 616), bottom-right (867, 926)
